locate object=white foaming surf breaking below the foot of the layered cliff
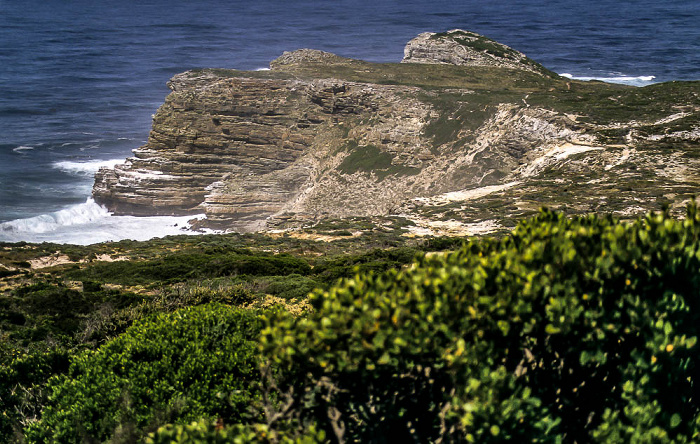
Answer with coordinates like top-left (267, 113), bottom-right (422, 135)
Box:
top-left (0, 198), bottom-right (212, 245)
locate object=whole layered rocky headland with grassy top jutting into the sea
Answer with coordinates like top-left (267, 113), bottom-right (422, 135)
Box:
top-left (93, 30), bottom-right (700, 234)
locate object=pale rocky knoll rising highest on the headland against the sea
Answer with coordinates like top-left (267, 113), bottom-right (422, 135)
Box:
top-left (401, 29), bottom-right (552, 75)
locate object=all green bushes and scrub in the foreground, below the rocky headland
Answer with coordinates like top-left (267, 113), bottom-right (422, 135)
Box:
top-left (0, 204), bottom-right (700, 443)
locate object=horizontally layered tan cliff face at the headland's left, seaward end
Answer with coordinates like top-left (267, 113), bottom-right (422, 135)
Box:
top-left (93, 73), bottom-right (323, 215)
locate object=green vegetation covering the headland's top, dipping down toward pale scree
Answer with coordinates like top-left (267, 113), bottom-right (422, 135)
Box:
top-left (192, 49), bottom-right (700, 145)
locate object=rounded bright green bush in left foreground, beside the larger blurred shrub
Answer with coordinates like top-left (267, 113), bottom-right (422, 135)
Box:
top-left (26, 304), bottom-right (260, 442)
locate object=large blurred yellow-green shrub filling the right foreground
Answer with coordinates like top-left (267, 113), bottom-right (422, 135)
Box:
top-left (261, 204), bottom-right (700, 442)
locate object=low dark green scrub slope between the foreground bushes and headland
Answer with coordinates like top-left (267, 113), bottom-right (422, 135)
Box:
top-left (0, 232), bottom-right (424, 442)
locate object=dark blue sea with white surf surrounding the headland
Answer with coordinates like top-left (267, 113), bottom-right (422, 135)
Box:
top-left (0, 0), bottom-right (700, 243)
